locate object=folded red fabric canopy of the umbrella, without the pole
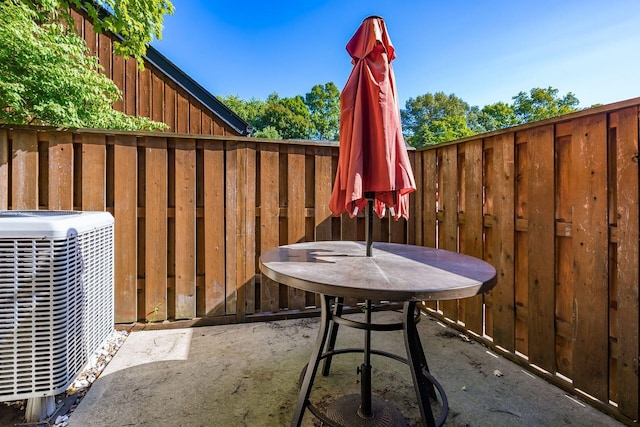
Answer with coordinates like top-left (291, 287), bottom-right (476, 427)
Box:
top-left (329, 16), bottom-right (416, 219)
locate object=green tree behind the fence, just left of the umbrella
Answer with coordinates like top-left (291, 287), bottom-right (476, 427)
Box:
top-left (304, 82), bottom-right (340, 141)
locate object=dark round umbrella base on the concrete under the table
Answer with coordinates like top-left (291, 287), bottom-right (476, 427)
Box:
top-left (327, 394), bottom-right (407, 427)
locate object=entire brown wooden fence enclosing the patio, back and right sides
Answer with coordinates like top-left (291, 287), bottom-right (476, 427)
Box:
top-left (0, 99), bottom-right (640, 421)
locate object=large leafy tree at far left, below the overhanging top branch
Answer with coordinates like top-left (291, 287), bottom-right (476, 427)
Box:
top-left (0, 0), bottom-right (167, 130)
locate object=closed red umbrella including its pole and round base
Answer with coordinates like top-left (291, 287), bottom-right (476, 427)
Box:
top-left (323, 16), bottom-right (416, 426)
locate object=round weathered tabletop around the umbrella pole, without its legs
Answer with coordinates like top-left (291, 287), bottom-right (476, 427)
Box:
top-left (260, 241), bottom-right (496, 301)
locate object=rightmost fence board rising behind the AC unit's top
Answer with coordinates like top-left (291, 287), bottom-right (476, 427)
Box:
top-left (82, 134), bottom-right (107, 211)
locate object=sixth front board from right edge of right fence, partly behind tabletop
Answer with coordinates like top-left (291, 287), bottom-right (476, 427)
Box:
top-left (438, 145), bottom-right (458, 320)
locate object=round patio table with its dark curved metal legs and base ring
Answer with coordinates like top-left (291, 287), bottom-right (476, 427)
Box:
top-left (260, 241), bottom-right (496, 427)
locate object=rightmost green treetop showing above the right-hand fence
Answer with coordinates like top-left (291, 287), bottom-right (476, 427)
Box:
top-left (513, 87), bottom-right (580, 123)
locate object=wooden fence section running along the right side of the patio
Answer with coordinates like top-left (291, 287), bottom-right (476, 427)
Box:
top-left (411, 99), bottom-right (639, 419)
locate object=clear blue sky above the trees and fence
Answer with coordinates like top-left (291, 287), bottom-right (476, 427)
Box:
top-left (152, 0), bottom-right (640, 108)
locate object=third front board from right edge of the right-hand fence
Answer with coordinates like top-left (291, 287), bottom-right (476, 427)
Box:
top-left (526, 125), bottom-right (555, 372)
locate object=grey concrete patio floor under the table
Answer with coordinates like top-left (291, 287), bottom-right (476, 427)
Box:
top-left (61, 312), bottom-right (622, 427)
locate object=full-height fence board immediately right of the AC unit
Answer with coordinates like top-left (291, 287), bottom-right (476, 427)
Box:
top-left (113, 136), bottom-right (138, 323)
